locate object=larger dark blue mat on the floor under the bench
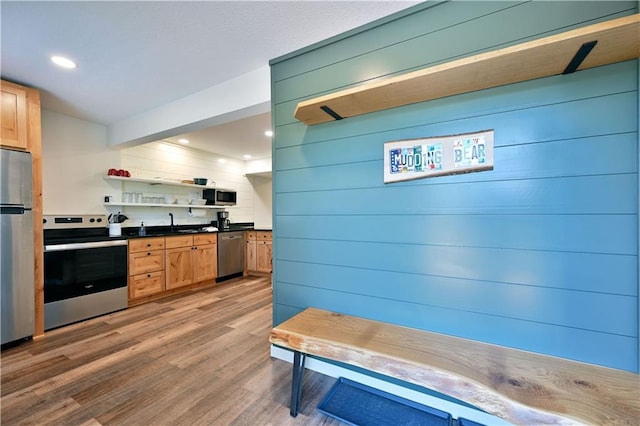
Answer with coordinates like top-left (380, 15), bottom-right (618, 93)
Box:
top-left (318, 377), bottom-right (452, 426)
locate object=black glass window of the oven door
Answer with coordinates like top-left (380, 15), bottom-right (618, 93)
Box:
top-left (44, 246), bottom-right (127, 303)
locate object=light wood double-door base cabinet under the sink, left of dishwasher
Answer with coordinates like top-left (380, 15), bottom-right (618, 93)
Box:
top-left (166, 234), bottom-right (218, 290)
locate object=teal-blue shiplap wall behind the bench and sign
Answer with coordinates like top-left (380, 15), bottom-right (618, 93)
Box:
top-left (271, 1), bottom-right (639, 372)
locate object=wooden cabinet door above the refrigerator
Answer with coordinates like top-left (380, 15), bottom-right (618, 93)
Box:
top-left (0, 84), bottom-right (27, 150)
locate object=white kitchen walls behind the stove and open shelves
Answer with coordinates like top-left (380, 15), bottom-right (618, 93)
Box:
top-left (42, 110), bottom-right (271, 228)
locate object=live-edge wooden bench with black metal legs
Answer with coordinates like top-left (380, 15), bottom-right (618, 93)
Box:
top-left (269, 308), bottom-right (640, 425)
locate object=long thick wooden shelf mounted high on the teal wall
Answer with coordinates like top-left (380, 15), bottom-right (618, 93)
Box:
top-left (294, 14), bottom-right (640, 125)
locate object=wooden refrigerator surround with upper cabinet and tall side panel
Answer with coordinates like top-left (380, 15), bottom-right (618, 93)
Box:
top-left (0, 80), bottom-right (44, 336)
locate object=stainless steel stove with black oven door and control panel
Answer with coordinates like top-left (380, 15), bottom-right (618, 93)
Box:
top-left (44, 215), bottom-right (127, 330)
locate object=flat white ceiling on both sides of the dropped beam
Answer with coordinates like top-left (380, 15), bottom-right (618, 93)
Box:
top-left (0, 0), bottom-right (419, 159)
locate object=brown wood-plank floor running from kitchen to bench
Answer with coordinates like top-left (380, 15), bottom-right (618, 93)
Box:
top-left (0, 277), bottom-right (341, 426)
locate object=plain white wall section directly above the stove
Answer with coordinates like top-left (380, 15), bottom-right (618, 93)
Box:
top-left (42, 109), bottom-right (120, 214)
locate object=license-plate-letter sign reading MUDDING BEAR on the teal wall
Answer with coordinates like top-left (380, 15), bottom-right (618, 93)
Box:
top-left (384, 130), bottom-right (493, 183)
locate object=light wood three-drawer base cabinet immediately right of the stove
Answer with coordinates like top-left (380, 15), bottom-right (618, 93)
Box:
top-left (129, 237), bottom-right (165, 300)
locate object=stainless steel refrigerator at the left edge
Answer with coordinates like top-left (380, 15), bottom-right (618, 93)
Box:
top-left (0, 149), bottom-right (35, 344)
